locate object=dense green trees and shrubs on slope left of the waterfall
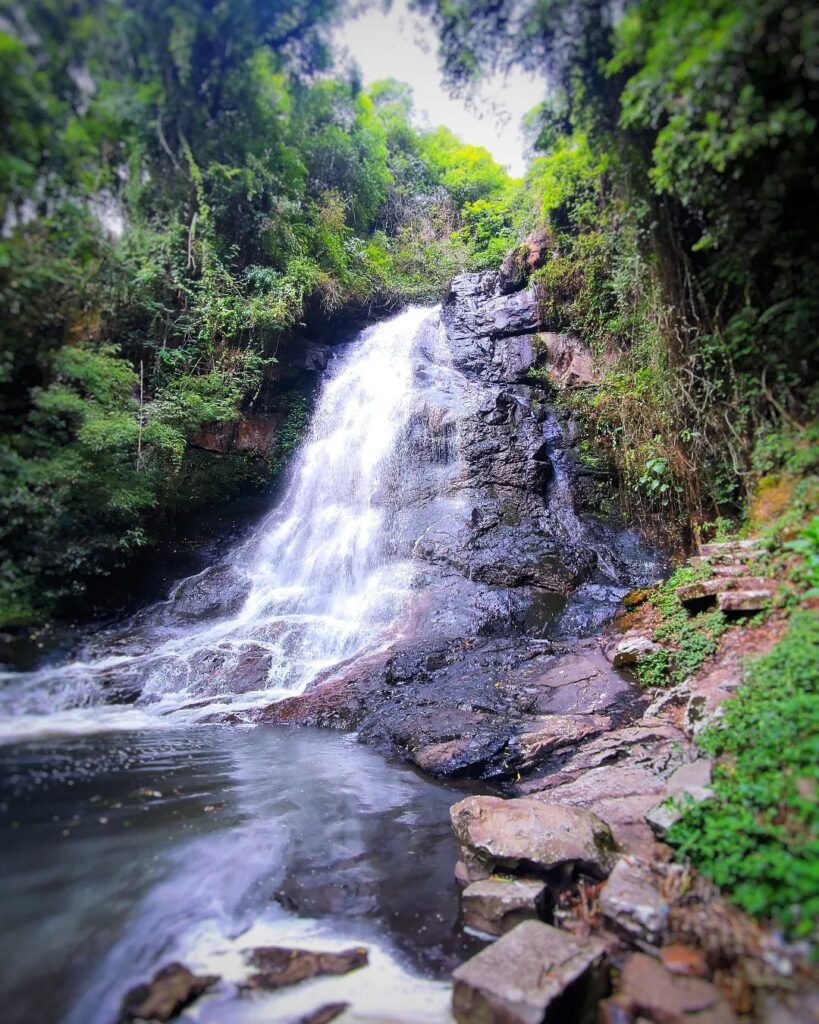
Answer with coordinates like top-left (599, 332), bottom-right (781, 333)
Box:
top-left (0, 0), bottom-right (519, 624)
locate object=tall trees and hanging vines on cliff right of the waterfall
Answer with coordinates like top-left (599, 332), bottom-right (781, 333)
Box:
top-left (418, 0), bottom-right (819, 536)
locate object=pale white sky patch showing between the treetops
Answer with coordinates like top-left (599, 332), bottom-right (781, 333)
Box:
top-left (335, 0), bottom-right (544, 176)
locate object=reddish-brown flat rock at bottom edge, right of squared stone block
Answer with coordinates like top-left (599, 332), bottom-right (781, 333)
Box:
top-left (603, 953), bottom-right (736, 1024)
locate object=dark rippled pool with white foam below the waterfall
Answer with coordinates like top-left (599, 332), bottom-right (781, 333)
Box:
top-left (0, 726), bottom-right (475, 1024)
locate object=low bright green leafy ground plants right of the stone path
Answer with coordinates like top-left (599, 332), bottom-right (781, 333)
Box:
top-left (670, 611), bottom-right (819, 939)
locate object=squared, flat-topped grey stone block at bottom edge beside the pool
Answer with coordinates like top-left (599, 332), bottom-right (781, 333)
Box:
top-left (452, 921), bottom-right (604, 1024)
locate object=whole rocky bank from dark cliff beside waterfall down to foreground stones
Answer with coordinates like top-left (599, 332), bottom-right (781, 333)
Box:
top-left (264, 273), bottom-right (816, 1024)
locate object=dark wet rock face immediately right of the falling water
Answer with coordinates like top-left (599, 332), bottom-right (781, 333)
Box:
top-left (262, 268), bottom-right (661, 780)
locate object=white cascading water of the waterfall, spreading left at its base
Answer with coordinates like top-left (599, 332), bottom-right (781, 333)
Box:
top-left (0, 307), bottom-right (447, 741)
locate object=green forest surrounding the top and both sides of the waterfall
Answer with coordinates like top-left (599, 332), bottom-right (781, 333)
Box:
top-left (0, 0), bottom-right (819, 624)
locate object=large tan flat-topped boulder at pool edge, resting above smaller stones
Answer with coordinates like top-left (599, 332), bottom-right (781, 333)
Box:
top-left (449, 797), bottom-right (616, 882)
